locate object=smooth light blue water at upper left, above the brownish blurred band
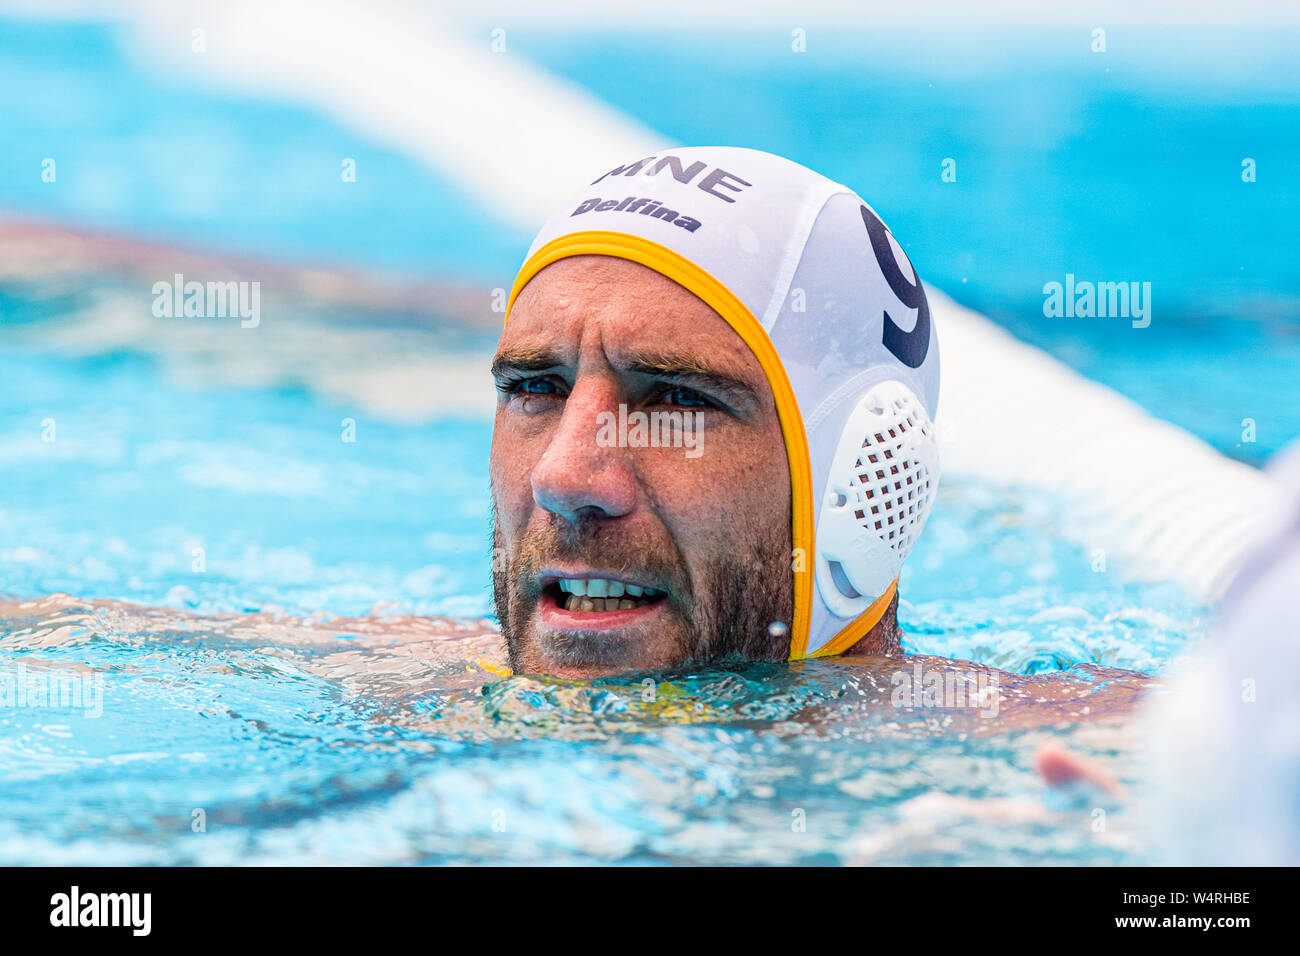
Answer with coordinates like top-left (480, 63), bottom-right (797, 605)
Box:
top-left (0, 18), bottom-right (527, 285)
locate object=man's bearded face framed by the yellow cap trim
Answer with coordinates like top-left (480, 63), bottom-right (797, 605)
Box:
top-left (491, 256), bottom-right (793, 678)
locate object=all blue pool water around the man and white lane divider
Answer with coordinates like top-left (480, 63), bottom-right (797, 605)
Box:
top-left (0, 14), bottom-right (1268, 864)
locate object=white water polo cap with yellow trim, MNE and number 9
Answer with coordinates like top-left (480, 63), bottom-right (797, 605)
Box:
top-left (506, 146), bottom-right (939, 659)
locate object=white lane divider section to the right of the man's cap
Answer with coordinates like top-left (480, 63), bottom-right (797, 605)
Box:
top-left (930, 290), bottom-right (1283, 600)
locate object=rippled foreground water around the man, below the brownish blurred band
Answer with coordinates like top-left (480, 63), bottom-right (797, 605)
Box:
top-left (0, 278), bottom-right (1204, 864)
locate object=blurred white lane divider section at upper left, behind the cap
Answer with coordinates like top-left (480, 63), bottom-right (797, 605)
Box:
top-left (122, 0), bottom-right (668, 230)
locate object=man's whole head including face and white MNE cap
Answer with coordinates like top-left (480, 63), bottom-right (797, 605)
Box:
top-left (491, 147), bottom-right (939, 676)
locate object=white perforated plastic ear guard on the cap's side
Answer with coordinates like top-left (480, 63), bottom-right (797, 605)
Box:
top-left (816, 381), bottom-right (939, 618)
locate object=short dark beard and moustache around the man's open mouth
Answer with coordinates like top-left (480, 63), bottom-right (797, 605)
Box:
top-left (493, 509), bottom-right (794, 674)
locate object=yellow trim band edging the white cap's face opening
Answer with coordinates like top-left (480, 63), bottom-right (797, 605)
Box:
top-left (506, 230), bottom-right (815, 661)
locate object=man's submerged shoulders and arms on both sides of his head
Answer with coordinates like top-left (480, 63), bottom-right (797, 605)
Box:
top-left (0, 594), bottom-right (1151, 735)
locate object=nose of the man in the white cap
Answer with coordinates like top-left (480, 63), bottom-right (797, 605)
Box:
top-left (532, 381), bottom-right (637, 520)
